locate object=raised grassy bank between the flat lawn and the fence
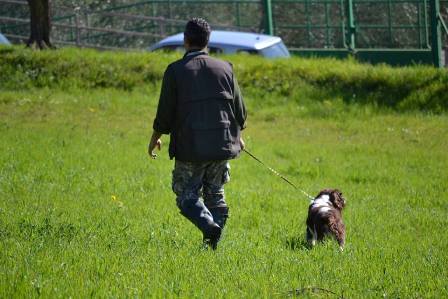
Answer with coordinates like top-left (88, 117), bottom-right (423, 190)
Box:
top-left (0, 47), bottom-right (448, 112)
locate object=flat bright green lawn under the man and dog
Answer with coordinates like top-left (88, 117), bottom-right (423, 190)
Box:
top-left (0, 49), bottom-right (448, 298)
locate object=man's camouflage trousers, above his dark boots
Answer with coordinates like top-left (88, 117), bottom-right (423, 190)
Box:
top-left (172, 160), bottom-right (230, 210)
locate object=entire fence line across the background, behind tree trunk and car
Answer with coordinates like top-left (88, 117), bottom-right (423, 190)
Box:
top-left (0, 0), bottom-right (448, 65)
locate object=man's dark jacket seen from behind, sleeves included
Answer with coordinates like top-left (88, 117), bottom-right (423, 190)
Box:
top-left (153, 52), bottom-right (246, 162)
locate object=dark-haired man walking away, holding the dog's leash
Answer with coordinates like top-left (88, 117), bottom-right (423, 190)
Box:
top-left (148, 18), bottom-right (247, 249)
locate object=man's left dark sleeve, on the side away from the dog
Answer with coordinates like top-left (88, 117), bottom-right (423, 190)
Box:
top-left (153, 66), bottom-right (177, 134)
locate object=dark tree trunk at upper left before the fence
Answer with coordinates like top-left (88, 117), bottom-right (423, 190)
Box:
top-left (26, 0), bottom-right (54, 49)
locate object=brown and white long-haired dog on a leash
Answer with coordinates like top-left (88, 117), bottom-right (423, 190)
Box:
top-left (306, 189), bottom-right (345, 250)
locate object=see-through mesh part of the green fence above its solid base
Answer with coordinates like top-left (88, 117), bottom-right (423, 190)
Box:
top-left (272, 0), bottom-right (436, 48)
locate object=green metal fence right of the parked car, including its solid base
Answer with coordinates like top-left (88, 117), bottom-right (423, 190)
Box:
top-left (272, 0), bottom-right (448, 65)
